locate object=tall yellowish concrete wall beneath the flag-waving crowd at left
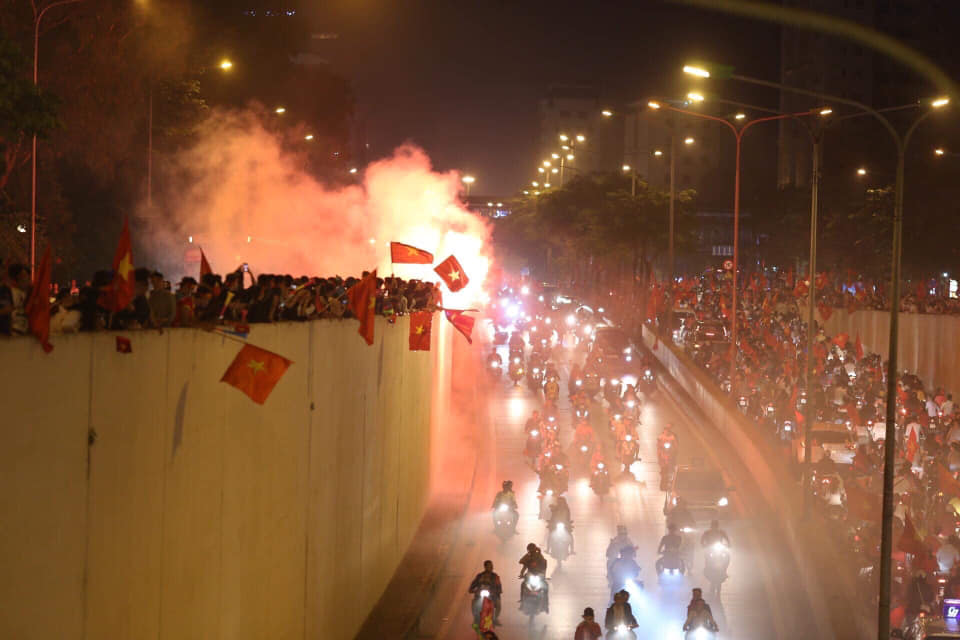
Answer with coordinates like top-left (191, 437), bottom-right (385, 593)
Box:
top-left (0, 318), bottom-right (442, 640)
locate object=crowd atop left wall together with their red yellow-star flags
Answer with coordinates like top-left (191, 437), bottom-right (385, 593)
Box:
top-left (0, 226), bottom-right (474, 404)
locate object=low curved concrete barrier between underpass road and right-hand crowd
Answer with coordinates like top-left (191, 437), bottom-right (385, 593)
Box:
top-left (643, 325), bottom-right (859, 638)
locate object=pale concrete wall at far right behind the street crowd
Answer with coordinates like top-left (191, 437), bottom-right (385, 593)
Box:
top-left (817, 309), bottom-right (960, 393)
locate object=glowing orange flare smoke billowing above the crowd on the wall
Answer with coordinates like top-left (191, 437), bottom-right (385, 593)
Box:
top-left (147, 111), bottom-right (489, 301)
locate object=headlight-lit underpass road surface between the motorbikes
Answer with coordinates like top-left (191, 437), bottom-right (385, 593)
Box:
top-left (420, 330), bottom-right (806, 640)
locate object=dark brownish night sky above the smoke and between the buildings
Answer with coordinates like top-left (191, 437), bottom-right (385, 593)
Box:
top-left (304, 0), bottom-right (779, 194)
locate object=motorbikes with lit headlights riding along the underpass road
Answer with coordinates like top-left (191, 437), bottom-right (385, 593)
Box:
top-left (471, 288), bottom-right (730, 640)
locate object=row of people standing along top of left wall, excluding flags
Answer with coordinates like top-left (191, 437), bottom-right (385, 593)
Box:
top-left (0, 263), bottom-right (440, 335)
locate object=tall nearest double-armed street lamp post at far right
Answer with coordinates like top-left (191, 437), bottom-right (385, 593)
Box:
top-left (684, 61), bottom-right (949, 640)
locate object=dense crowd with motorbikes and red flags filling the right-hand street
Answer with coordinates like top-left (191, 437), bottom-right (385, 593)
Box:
top-left (632, 270), bottom-right (960, 626)
